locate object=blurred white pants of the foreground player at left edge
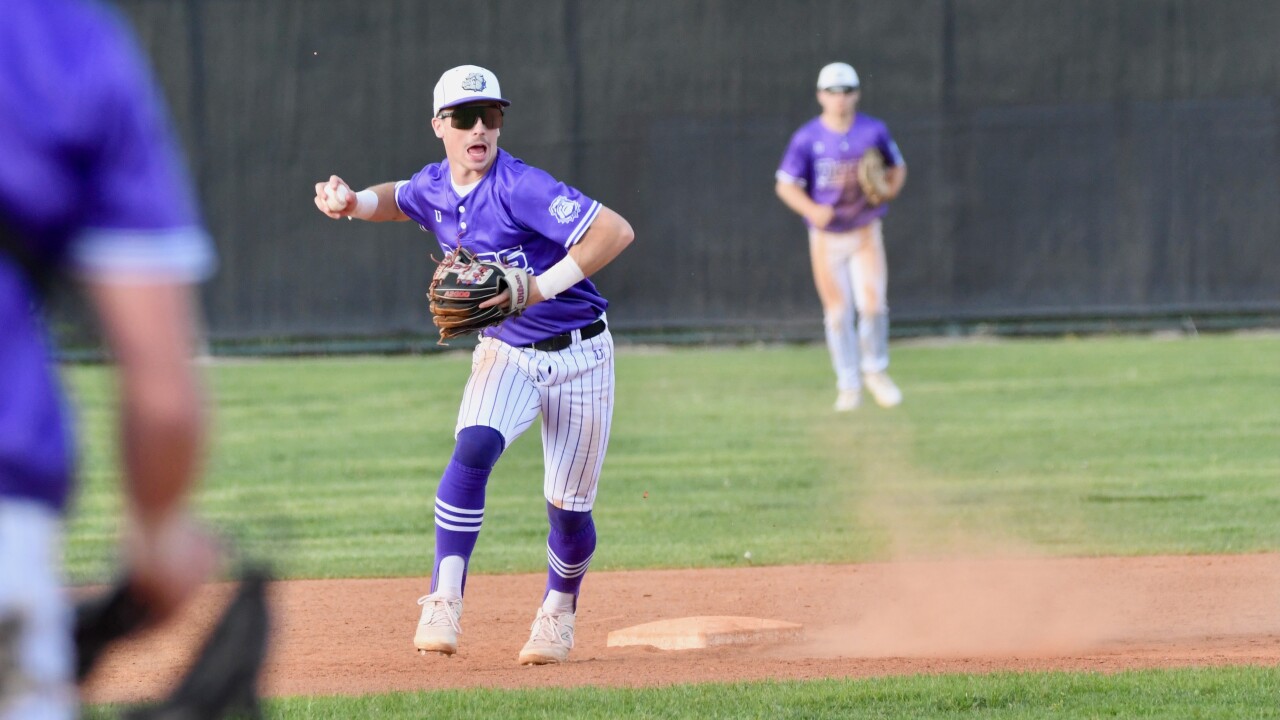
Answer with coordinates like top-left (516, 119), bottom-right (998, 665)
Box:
top-left (0, 498), bottom-right (77, 720)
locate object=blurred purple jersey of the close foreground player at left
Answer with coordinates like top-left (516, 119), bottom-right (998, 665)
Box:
top-left (0, 0), bottom-right (214, 510)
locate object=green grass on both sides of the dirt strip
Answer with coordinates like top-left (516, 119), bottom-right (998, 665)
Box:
top-left (67, 334), bottom-right (1280, 717)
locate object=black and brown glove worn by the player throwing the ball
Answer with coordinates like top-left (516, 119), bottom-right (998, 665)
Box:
top-left (426, 246), bottom-right (531, 345)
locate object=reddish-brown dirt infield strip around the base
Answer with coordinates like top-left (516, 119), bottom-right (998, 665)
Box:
top-left (87, 553), bottom-right (1280, 702)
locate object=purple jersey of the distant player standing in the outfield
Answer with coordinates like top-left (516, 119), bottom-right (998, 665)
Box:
top-left (776, 113), bottom-right (902, 232)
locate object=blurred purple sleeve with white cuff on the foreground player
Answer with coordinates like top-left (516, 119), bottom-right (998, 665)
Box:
top-left (69, 14), bottom-right (215, 282)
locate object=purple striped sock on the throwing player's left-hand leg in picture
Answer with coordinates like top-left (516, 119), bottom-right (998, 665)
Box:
top-left (431, 425), bottom-right (503, 597)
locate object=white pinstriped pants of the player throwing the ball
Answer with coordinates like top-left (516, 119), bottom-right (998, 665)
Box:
top-left (454, 319), bottom-right (613, 512)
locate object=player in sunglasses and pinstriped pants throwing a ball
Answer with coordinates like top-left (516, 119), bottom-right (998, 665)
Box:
top-left (315, 65), bottom-right (634, 665)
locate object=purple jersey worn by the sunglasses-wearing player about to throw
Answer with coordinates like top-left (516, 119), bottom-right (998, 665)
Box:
top-left (396, 149), bottom-right (608, 345)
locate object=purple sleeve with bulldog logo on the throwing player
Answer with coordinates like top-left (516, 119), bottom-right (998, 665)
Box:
top-left (508, 168), bottom-right (600, 247)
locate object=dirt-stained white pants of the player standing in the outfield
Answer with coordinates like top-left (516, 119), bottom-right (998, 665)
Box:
top-left (809, 220), bottom-right (888, 391)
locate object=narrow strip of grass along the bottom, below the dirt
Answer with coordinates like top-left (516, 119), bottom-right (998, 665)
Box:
top-left (87, 667), bottom-right (1280, 720)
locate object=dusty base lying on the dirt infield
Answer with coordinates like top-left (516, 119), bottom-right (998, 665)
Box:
top-left (608, 615), bottom-right (804, 650)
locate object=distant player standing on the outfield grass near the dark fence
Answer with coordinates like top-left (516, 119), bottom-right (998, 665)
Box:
top-left (777, 63), bottom-right (906, 411)
